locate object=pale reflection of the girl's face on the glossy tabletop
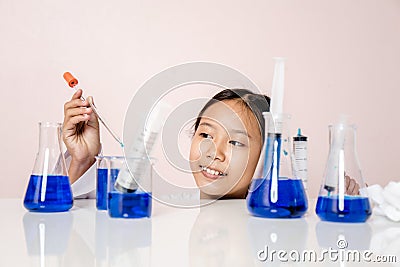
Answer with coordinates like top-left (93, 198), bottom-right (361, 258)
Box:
top-left (189, 202), bottom-right (252, 267)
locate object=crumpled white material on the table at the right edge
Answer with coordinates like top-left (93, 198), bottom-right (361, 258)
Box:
top-left (367, 182), bottom-right (400, 222)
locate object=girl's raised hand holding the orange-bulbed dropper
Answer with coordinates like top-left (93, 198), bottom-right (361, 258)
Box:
top-left (62, 89), bottom-right (100, 183)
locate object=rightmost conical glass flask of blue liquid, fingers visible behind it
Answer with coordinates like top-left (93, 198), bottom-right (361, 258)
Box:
top-left (315, 122), bottom-right (371, 222)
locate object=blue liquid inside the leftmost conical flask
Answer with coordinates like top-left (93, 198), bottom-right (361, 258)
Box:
top-left (24, 175), bottom-right (73, 212)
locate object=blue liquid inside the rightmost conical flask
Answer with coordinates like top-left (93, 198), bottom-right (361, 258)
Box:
top-left (315, 196), bottom-right (372, 222)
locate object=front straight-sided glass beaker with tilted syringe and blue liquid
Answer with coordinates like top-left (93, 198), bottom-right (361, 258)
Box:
top-left (107, 157), bottom-right (153, 218)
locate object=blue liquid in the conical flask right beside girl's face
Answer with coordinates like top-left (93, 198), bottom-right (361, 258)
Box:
top-left (247, 178), bottom-right (308, 218)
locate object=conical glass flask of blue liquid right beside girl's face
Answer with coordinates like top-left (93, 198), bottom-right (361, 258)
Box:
top-left (247, 112), bottom-right (308, 218)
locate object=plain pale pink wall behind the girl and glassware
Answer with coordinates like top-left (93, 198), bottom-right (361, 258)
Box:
top-left (0, 0), bottom-right (400, 198)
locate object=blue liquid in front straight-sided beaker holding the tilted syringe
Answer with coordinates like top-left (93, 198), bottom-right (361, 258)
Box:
top-left (108, 191), bottom-right (151, 218)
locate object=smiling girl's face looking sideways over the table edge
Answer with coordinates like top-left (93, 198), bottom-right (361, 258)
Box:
top-left (190, 100), bottom-right (261, 198)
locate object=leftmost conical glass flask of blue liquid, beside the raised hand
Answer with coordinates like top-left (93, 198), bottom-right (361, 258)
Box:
top-left (24, 122), bottom-right (73, 212)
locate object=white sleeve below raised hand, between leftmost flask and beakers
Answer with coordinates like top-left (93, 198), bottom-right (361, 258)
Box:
top-left (64, 151), bottom-right (96, 198)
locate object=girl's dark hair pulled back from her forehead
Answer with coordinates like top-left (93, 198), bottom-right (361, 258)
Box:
top-left (194, 89), bottom-right (271, 142)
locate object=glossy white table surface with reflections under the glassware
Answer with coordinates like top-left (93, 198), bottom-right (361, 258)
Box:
top-left (0, 199), bottom-right (400, 267)
